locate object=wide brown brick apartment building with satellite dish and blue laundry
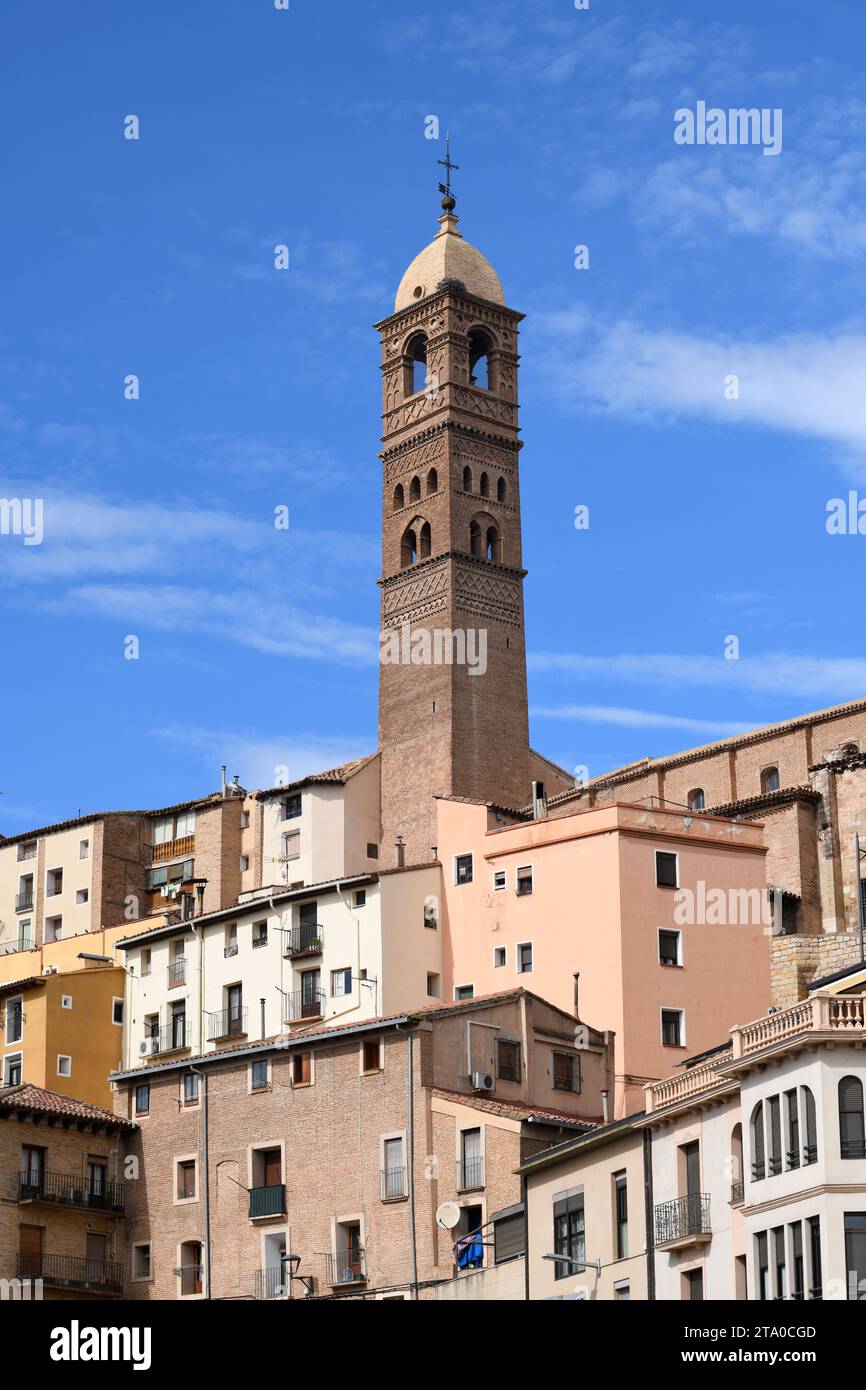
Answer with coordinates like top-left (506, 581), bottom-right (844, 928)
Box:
top-left (113, 988), bottom-right (613, 1298)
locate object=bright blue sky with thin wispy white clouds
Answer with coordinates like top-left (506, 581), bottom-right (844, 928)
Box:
top-left (0, 0), bottom-right (866, 834)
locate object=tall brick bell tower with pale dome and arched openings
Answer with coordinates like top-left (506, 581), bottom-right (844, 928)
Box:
top-left (375, 180), bottom-right (531, 865)
